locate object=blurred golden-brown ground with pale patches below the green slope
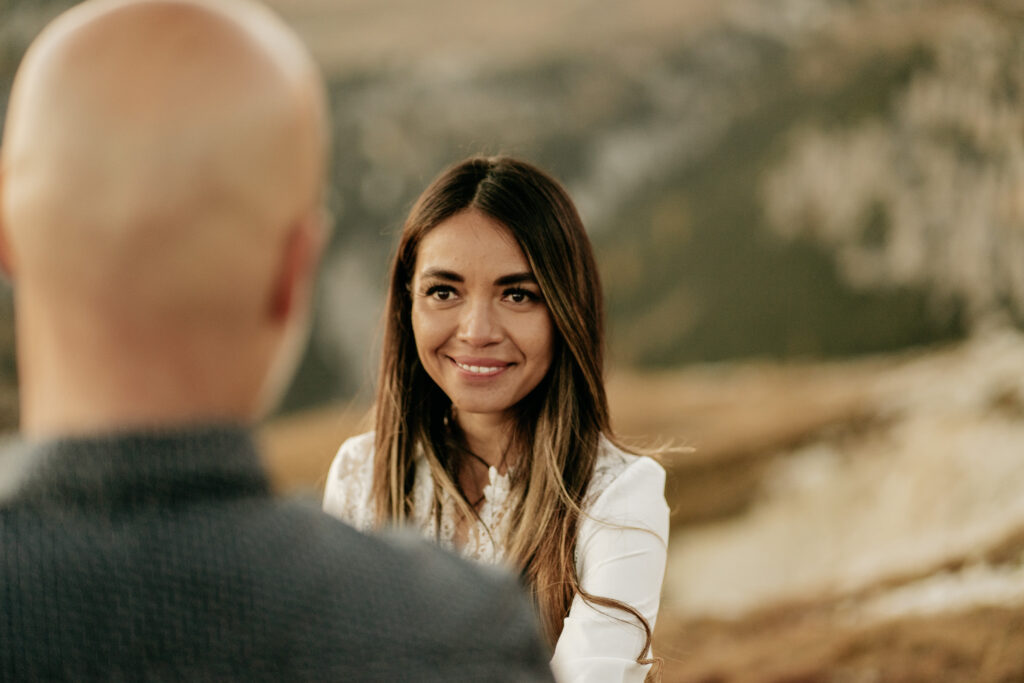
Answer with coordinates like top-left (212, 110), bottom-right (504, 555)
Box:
top-left (264, 332), bottom-right (1024, 683)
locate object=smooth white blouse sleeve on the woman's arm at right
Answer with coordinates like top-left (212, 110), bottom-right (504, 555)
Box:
top-left (551, 458), bottom-right (669, 683)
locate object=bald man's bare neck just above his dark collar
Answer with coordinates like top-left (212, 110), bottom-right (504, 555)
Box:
top-left (17, 301), bottom-right (262, 438)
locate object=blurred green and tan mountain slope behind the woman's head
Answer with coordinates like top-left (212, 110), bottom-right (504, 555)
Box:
top-left (0, 0), bottom-right (1024, 417)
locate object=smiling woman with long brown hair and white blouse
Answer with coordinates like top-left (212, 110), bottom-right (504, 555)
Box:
top-left (324, 157), bottom-right (669, 681)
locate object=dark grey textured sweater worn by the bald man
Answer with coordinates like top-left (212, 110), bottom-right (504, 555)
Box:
top-left (0, 426), bottom-right (551, 681)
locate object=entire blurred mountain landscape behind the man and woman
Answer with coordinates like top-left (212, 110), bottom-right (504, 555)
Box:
top-left (0, 0), bottom-right (1024, 683)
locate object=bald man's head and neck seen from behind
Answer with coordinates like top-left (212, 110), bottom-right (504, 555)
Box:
top-left (0, 0), bottom-right (327, 433)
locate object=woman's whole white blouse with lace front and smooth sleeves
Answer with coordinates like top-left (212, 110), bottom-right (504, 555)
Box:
top-left (324, 432), bottom-right (669, 683)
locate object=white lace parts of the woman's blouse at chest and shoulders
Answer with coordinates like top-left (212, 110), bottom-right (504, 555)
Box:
top-left (324, 432), bottom-right (637, 564)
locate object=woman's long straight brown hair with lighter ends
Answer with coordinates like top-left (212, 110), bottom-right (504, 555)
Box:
top-left (374, 157), bottom-right (651, 664)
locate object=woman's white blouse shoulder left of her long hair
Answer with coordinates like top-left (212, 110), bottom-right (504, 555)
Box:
top-left (324, 432), bottom-right (374, 530)
